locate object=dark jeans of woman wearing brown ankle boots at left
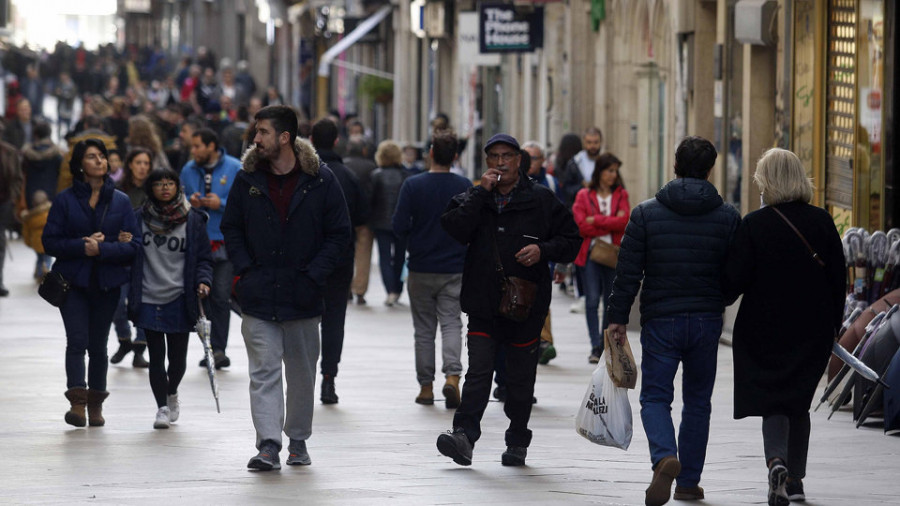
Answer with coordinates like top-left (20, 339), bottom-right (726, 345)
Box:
top-left (59, 287), bottom-right (119, 390)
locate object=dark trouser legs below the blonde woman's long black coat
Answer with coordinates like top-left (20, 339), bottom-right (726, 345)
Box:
top-left (763, 412), bottom-right (810, 479)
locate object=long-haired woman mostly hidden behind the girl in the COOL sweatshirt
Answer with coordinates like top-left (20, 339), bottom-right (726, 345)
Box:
top-left (109, 148), bottom-right (153, 368)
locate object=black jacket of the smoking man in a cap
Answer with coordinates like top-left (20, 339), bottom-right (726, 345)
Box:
top-left (441, 174), bottom-right (581, 321)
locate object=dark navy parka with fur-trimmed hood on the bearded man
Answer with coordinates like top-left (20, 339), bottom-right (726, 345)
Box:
top-left (219, 138), bottom-right (352, 321)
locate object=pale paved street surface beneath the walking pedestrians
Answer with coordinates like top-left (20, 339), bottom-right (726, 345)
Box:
top-left (0, 240), bottom-right (900, 506)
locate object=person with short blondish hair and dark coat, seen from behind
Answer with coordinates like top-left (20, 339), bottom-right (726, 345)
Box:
top-left (369, 140), bottom-right (409, 306)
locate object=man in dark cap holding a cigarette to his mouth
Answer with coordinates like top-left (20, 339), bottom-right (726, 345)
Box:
top-left (437, 134), bottom-right (581, 466)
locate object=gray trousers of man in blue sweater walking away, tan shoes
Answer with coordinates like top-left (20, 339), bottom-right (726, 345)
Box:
top-left (407, 272), bottom-right (462, 385)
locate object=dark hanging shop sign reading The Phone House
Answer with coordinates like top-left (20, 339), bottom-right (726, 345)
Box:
top-left (478, 3), bottom-right (544, 53)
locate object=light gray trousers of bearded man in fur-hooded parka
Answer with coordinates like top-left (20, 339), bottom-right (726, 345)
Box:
top-left (241, 314), bottom-right (320, 449)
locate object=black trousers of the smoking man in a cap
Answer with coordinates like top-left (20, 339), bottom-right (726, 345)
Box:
top-left (453, 313), bottom-right (547, 447)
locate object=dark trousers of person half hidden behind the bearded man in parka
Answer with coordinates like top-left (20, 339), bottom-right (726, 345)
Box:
top-left (322, 257), bottom-right (353, 378)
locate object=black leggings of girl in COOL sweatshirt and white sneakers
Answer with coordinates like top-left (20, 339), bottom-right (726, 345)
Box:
top-left (144, 330), bottom-right (190, 408)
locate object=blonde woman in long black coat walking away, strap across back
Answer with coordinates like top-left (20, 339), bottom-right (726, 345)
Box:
top-left (724, 148), bottom-right (847, 505)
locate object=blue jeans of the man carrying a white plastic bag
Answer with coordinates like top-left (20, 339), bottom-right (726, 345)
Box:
top-left (640, 313), bottom-right (722, 487)
